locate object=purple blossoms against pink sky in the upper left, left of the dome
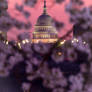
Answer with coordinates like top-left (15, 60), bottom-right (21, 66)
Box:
top-left (0, 0), bottom-right (31, 31)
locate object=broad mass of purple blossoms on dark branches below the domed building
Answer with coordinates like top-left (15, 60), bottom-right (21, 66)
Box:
top-left (0, 32), bottom-right (92, 92)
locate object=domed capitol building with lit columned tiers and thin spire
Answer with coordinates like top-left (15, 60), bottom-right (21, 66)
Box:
top-left (32, 0), bottom-right (58, 43)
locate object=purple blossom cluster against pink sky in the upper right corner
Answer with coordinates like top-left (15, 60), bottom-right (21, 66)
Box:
top-left (66, 0), bottom-right (92, 30)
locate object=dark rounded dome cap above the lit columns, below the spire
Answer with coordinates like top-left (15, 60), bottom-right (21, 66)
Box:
top-left (36, 14), bottom-right (52, 26)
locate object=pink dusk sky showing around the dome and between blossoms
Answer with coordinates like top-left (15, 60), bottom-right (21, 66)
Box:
top-left (7, 0), bottom-right (92, 40)
